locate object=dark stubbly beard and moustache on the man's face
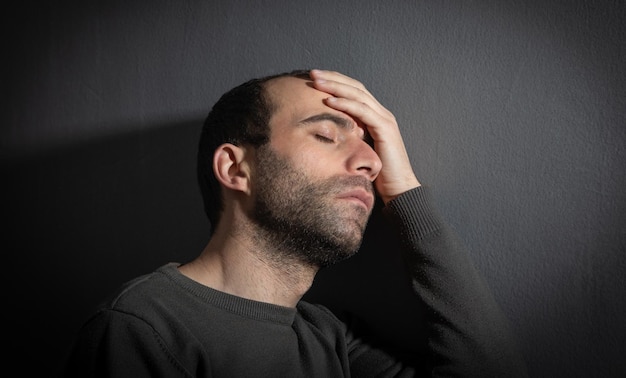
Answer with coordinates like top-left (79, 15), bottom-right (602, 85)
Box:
top-left (251, 145), bottom-right (373, 268)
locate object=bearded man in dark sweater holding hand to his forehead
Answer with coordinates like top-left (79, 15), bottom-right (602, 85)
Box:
top-left (67, 70), bottom-right (524, 377)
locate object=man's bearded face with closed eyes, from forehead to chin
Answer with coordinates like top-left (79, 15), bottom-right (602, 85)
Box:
top-left (252, 78), bottom-right (381, 266)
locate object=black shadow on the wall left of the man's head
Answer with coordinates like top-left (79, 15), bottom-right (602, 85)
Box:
top-left (3, 121), bottom-right (208, 376)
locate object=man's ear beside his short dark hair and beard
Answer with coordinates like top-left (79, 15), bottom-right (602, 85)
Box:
top-left (213, 143), bottom-right (250, 194)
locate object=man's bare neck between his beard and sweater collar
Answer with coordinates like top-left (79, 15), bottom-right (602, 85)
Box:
top-left (179, 219), bottom-right (318, 307)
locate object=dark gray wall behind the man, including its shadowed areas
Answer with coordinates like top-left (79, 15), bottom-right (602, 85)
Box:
top-left (6, 0), bottom-right (626, 377)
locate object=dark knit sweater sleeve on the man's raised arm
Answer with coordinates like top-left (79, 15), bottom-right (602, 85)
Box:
top-left (384, 187), bottom-right (526, 378)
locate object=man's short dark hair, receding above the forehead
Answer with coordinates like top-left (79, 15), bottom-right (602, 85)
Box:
top-left (197, 70), bottom-right (310, 230)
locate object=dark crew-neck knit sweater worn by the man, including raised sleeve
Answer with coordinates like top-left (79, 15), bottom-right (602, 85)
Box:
top-left (66, 188), bottom-right (525, 378)
